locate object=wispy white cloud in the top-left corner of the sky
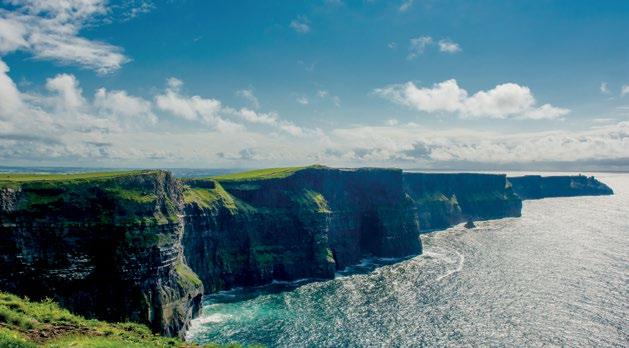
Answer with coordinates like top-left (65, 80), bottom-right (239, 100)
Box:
top-left (0, 0), bottom-right (129, 73)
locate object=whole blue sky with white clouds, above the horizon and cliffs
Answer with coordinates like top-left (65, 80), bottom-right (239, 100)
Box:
top-left (0, 0), bottom-right (629, 170)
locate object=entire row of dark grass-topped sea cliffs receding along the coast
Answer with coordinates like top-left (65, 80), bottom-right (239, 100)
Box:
top-left (0, 166), bottom-right (611, 336)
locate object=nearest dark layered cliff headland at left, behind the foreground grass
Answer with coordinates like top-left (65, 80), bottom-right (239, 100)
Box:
top-left (0, 171), bottom-right (203, 336)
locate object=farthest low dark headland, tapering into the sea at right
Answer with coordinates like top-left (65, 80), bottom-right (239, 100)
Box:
top-left (509, 175), bottom-right (614, 199)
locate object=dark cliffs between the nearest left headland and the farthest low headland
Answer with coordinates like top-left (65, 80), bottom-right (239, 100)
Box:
top-left (183, 167), bottom-right (522, 292)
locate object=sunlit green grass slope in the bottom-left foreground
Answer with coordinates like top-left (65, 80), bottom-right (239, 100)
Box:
top-left (0, 290), bottom-right (222, 348)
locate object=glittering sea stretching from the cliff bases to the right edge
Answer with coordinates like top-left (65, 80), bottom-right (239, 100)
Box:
top-left (187, 174), bottom-right (629, 347)
